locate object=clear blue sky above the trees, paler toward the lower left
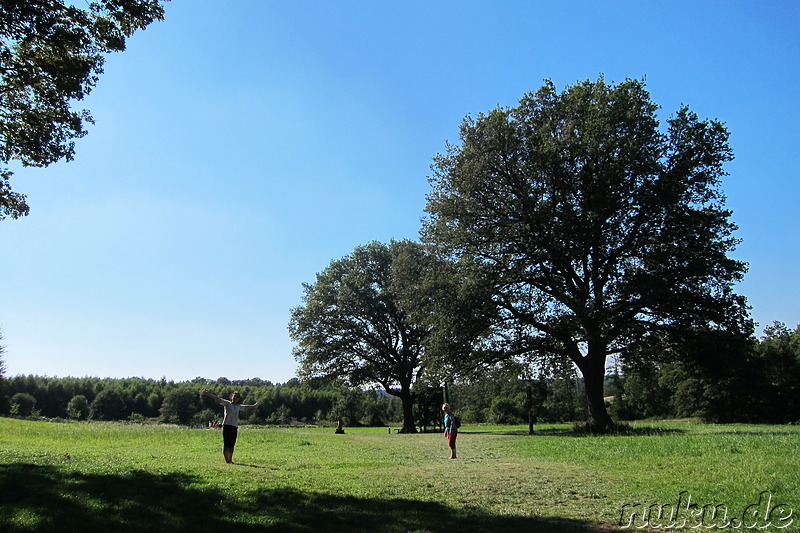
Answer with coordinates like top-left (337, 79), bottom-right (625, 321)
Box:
top-left (0, 0), bottom-right (800, 382)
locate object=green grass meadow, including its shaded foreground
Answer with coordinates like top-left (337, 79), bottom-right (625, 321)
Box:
top-left (0, 418), bottom-right (800, 533)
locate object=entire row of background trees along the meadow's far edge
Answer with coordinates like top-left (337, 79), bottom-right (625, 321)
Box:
top-left (0, 323), bottom-right (800, 426)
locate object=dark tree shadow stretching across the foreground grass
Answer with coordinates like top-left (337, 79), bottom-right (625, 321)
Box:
top-left (0, 463), bottom-right (599, 533)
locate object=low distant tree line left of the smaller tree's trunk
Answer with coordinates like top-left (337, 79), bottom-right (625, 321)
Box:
top-left (0, 375), bottom-right (402, 426)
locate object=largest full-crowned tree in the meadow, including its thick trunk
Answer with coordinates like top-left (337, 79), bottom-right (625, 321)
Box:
top-left (423, 78), bottom-right (752, 431)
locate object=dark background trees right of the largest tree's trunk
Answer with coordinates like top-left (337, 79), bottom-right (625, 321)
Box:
top-left (607, 322), bottom-right (800, 424)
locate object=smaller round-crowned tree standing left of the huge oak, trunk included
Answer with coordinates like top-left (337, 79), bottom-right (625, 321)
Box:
top-left (289, 240), bottom-right (440, 432)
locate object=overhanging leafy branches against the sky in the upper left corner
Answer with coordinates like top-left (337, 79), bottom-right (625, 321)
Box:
top-left (0, 0), bottom-right (166, 220)
